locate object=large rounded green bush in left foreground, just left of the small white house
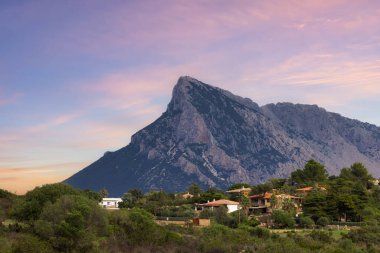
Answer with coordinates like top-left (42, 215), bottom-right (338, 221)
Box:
top-left (34, 195), bottom-right (107, 252)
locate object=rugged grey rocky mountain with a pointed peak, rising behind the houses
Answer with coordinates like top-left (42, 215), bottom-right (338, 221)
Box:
top-left (66, 77), bottom-right (380, 196)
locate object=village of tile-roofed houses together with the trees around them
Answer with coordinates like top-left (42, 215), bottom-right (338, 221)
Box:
top-left (99, 160), bottom-right (379, 231)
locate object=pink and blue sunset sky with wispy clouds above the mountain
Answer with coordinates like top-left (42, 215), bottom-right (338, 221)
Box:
top-left (0, 0), bottom-right (380, 194)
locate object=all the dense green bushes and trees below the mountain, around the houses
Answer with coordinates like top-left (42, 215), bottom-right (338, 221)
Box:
top-left (0, 161), bottom-right (380, 253)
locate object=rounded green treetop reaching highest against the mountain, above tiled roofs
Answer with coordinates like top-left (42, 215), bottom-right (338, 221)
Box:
top-left (291, 160), bottom-right (328, 185)
